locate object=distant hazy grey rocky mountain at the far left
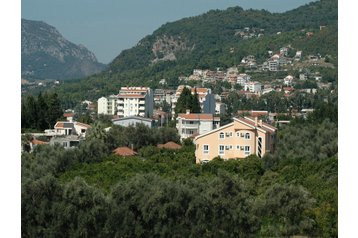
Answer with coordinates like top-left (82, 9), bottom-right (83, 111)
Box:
top-left (21, 19), bottom-right (105, 79)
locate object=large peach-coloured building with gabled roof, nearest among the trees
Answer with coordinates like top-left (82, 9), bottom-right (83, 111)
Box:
top-left (194, 117), bottom-right (277, 163)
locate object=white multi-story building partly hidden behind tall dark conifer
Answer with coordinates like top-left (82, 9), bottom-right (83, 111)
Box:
top-left (172, 85), bottom-right (215, 117)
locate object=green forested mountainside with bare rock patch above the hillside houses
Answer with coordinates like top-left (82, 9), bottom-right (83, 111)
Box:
top-left (26, 0), bottom-right (338, 104)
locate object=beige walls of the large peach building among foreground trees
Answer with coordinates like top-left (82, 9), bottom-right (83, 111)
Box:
top-left (195, 121), bottom-right (273, 163)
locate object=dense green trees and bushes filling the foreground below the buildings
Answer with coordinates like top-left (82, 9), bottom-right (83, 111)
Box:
top-left (21, 104), bottom-right (338, 237)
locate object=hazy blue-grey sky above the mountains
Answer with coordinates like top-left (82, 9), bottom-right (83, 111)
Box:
top-left (21, 0), bottom-right (313, 63)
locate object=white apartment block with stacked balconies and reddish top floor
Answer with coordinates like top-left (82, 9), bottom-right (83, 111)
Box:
top-left (117, 87), bottom-right (154, 117)
